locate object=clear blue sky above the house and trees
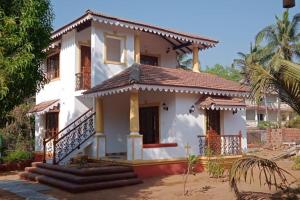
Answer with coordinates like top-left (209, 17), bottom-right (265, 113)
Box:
top-left (52, 0), bottom-right (300, 66)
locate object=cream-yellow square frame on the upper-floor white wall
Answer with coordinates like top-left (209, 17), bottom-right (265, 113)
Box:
top-left (103, 33), bottom-right (127, 65)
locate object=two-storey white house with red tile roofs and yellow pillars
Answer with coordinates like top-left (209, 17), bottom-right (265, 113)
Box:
top-left (31, 10), bottom-right (248, 169)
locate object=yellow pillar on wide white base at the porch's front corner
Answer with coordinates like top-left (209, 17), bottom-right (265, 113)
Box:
top-left (127, 91), bottom-right (143, 160)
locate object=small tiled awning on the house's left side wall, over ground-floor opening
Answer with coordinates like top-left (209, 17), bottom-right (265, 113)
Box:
top-left (28, 99), bottom-right (59, 115)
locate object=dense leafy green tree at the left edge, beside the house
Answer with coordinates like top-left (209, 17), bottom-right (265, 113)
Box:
top-left (0, 0), bottom-right (53, 127)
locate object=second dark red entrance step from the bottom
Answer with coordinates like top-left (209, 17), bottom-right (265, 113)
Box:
top-left (25, 167), bottom-right (137, 184)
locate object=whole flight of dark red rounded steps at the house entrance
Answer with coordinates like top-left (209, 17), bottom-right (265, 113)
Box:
top-left (19, 163), bottom-right (142, 193)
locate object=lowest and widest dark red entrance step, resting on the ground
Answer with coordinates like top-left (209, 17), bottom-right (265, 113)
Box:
top-left (20, 172), bottom-right (142, 193)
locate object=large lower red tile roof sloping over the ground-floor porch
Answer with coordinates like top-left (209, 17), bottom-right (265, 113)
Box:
top-left (84, 64), bottom-right (249, 94)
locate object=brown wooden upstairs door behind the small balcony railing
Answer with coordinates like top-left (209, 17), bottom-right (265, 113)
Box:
top-left (80, 46), bottom-right (91, 89)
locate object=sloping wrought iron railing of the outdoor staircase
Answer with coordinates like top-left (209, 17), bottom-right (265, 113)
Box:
top-left (43, 109), bottom-right (95, 164)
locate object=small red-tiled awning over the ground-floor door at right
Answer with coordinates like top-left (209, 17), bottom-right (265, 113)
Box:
top-left (196, 95), bottom-right (246, 108)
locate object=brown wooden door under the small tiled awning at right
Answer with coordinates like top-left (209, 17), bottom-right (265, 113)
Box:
top-left (206, 110), bottom-right (221, 155)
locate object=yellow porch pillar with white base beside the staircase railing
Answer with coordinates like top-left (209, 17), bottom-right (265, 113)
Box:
top-left (94, 98), bottom-right (106, 159)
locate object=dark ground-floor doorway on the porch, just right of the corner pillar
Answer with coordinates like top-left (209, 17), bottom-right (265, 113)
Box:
top-left (139, 106), bottom-right (159, 144)
